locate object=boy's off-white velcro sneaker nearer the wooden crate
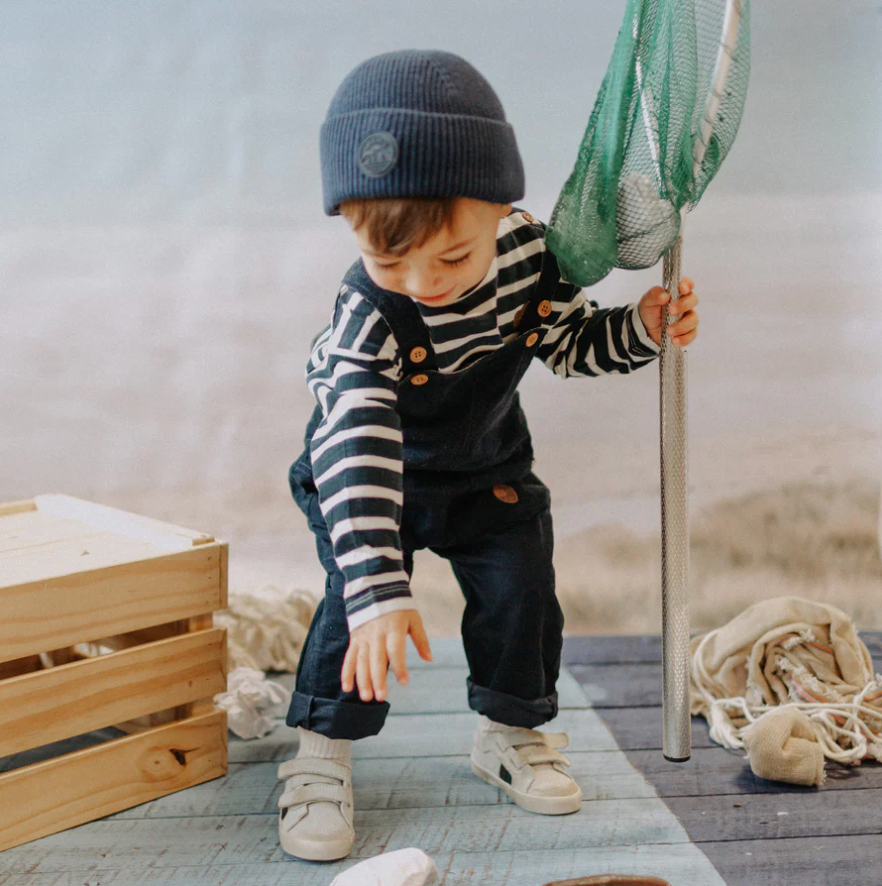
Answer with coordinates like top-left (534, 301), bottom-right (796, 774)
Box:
top-left (278, 757), bottom-right (355, 861)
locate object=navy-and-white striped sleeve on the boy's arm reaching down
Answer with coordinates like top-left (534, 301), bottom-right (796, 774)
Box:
top-left (306, 288), bottom-right (416, 631)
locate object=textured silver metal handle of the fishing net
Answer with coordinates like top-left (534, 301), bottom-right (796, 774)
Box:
top-left (659, 224), bottom-right (692, 763)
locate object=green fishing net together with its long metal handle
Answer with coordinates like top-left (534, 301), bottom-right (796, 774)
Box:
top-left (546, 0), bottom-right (750, 763)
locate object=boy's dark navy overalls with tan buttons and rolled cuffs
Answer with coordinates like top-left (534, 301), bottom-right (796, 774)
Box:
top-left (286, 246), bottom-right (563, 739)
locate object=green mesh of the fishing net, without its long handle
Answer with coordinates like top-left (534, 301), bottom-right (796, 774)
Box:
top-left (546, 0), bottom-right (750, 286)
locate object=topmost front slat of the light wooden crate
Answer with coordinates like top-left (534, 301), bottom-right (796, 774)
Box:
top-left (0, 543), bottom-right (225, 661)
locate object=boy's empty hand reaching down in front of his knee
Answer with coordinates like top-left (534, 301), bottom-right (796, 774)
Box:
top-left (340, 609), bottom-right (432, 701)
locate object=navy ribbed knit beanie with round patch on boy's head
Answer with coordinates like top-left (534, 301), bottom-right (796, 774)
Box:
top-left (320, 49), bottom-right (524, 215)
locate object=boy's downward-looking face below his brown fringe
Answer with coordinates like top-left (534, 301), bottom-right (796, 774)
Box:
top-left (353, 197), bottom-right (511, 308)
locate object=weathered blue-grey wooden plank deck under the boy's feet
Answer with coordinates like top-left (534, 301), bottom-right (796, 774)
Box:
top-left (0, 633), bottom-right (882, 886)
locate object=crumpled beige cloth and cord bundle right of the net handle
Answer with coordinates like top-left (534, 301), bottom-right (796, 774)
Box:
top-left (690, 597), bottom-right (882, 784)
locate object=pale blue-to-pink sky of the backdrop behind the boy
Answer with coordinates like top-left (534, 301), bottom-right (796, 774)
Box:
top-left (0, 0), bottom-right (882, 600)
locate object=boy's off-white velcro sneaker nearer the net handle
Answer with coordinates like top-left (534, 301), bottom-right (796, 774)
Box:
top-left (472, 726), bottom-right (582, 815)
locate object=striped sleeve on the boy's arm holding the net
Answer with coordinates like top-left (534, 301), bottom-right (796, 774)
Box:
top-left (536, 248), bottom-right (660, 378)
